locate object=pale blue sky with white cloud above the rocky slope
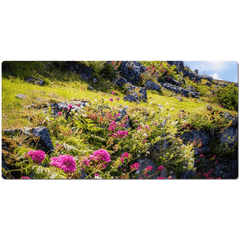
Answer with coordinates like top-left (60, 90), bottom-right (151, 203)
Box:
top-left (184, 61), bottom-right (238, 82)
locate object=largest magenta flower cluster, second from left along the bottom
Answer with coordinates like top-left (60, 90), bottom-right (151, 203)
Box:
top-left (49, 155), bottom-right (76, 173)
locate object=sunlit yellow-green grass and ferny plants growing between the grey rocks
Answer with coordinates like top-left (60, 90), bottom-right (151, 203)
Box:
top-left (2, 62), bottom-right (238, 178)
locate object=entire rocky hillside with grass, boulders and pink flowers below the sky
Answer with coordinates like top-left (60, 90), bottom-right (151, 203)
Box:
top-left (2, 61), bottom-right (238, 179)
